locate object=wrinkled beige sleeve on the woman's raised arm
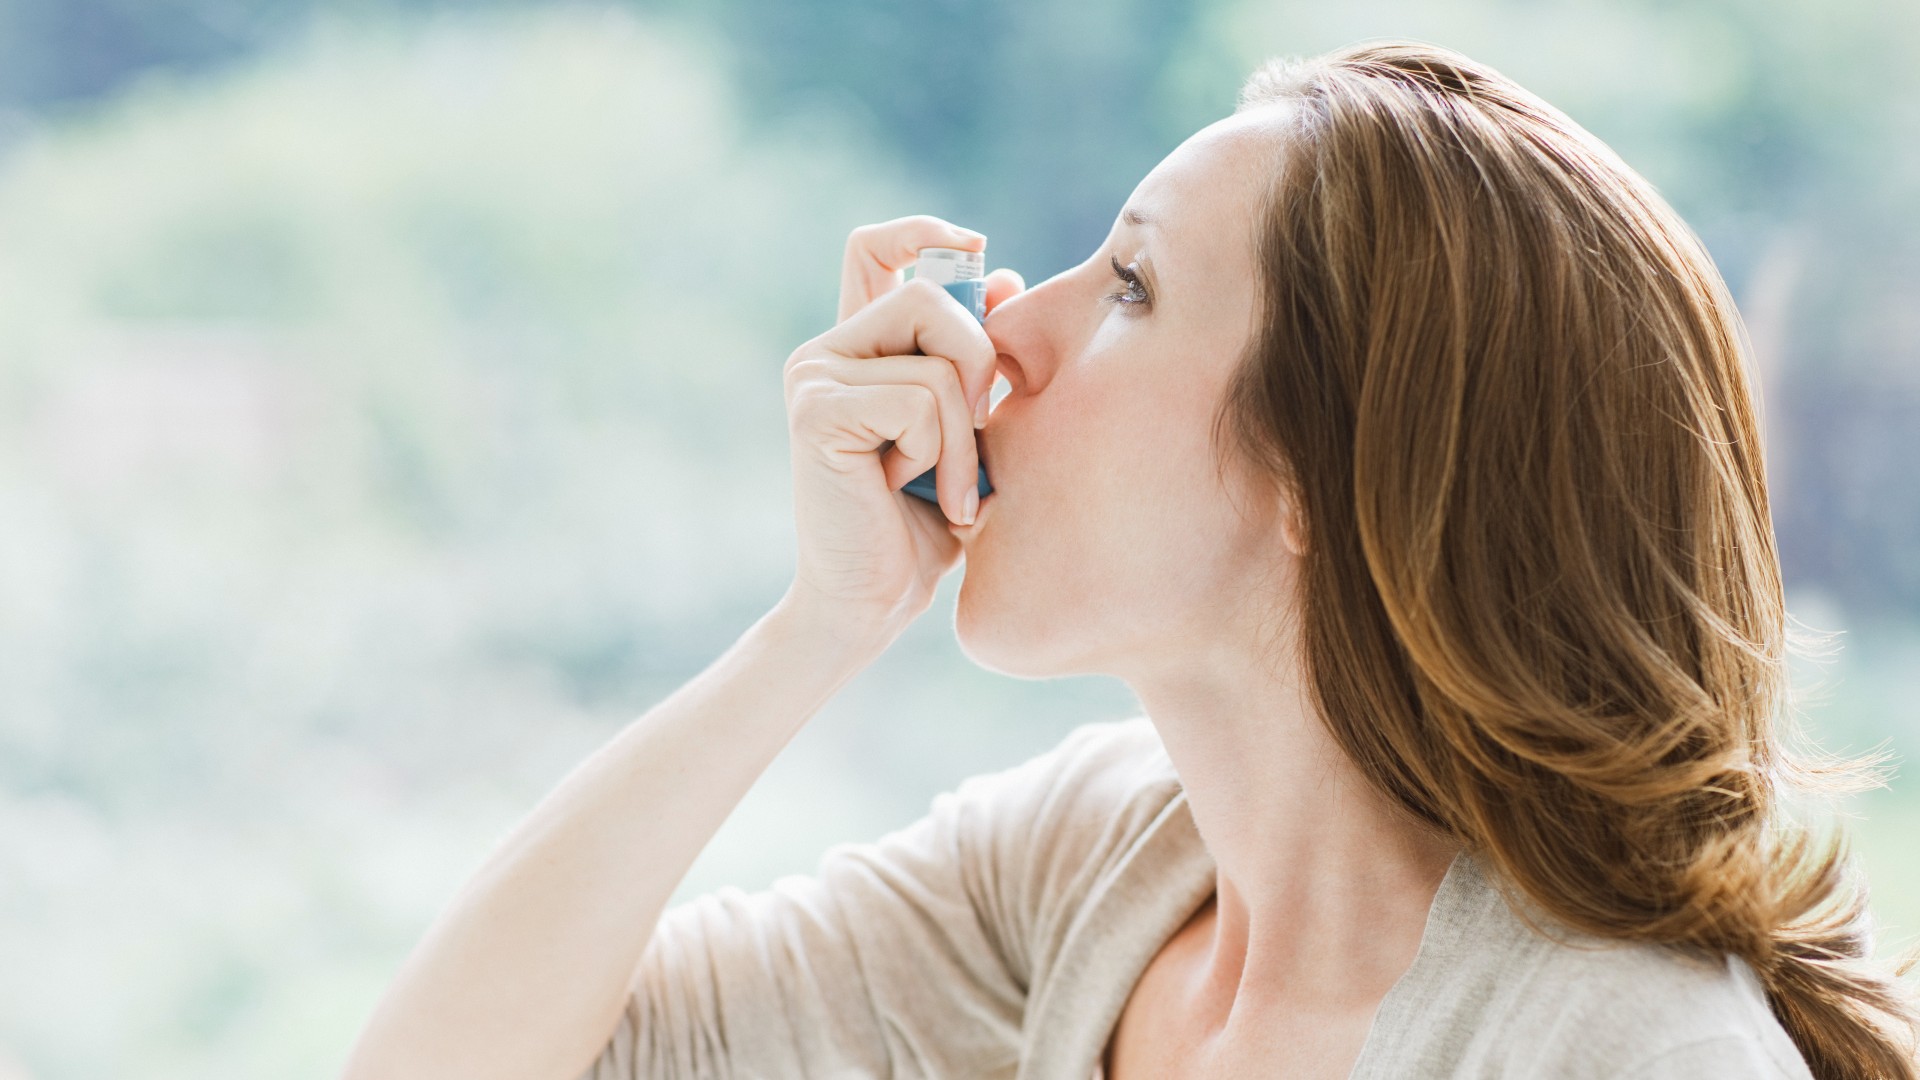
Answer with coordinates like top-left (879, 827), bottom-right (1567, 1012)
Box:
top-left (560, 724), bottom-right (1128, 1080)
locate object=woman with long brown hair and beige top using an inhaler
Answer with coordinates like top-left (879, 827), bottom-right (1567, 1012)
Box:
top-left (348, 42), bottom-right (1916, 1080)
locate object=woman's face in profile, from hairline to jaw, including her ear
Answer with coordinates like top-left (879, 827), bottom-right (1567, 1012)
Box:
top-left (954, 106), bottom-right (1298, 682)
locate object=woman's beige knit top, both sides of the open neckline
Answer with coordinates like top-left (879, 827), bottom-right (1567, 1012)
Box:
top-left (582, 717), bottom-right (1811, 1080)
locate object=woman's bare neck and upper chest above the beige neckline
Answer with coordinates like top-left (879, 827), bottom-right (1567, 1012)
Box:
top-left (1137, 641), bottom-right (1459, 1024)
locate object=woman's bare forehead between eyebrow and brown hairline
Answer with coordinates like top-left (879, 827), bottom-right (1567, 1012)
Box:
top-left (1127, 106), bottom-right (1284, 276)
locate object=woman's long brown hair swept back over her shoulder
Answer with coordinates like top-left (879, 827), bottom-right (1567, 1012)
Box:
top-left (1215, 40), bottom-right (1920, 1080)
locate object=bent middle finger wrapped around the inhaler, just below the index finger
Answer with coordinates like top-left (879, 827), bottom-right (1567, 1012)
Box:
top-left (808, 279), bottom-right (998, 418)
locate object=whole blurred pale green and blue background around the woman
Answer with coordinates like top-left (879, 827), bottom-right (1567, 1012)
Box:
top-left (0, 0), bottom-right (1920, 1080)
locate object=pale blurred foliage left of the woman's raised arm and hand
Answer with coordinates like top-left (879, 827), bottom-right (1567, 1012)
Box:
top-left (0, 10), bottom-right (960, 1078)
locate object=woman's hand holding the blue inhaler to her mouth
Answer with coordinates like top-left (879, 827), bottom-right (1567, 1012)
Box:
top-left (785, 215), bottom-right (1021, 632)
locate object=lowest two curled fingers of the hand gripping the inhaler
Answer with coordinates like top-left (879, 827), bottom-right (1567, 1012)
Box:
top-left (799, 356), bottom-right (979, 525)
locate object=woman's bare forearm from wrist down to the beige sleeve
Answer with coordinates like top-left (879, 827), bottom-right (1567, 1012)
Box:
top-left (346, 601), bottom-right (885, 1080)
